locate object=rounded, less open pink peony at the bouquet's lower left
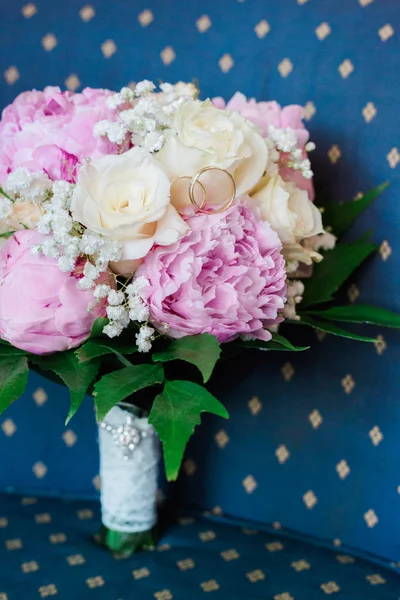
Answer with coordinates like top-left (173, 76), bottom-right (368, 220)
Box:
top-left (0, 230), bottom-right (108, 354)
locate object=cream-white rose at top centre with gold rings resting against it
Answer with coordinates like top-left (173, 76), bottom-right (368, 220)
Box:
top-left (156, 100), bottom-right (268, 210)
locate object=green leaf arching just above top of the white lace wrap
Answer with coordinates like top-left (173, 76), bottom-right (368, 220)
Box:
top-left (89, 363), bottom-right (164, 421)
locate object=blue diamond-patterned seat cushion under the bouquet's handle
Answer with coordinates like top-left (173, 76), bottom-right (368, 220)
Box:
top-left (0, 496), bottom-right (400, 600)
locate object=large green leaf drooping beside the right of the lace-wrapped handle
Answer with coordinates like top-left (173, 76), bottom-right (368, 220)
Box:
top-left (149, 381), bottom-right (229, 481)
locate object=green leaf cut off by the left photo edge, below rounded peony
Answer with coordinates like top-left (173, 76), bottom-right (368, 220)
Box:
top-left (0, 356), bottom-right (29, 413)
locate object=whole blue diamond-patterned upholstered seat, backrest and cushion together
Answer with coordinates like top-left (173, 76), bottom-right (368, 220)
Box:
top-left (0, 0), bottom-right (400, 600)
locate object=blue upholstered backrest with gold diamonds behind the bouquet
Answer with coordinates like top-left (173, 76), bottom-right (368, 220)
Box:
top-left (0, 0), bottom-right (400, 576)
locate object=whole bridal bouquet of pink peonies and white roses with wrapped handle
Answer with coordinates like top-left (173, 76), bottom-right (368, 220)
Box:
top-left (0, 81), bottom-right (400, 552)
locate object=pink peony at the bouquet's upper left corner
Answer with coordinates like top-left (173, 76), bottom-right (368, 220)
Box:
top-left (0, 87), bottom-right (115, 184)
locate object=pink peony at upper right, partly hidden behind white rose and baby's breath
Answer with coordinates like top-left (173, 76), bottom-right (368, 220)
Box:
top-left (213, 92), bottom-right (315, 200)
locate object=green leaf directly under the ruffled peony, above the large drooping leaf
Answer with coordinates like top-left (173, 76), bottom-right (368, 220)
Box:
top-left (153, 333), bottom-right (221, 383)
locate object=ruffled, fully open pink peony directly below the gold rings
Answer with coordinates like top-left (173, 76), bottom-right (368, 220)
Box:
top-left (137, 203), bottom-right (286, 342)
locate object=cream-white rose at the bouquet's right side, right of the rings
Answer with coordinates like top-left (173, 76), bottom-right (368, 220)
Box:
top-left (249, 175), bottom-right (324, 264)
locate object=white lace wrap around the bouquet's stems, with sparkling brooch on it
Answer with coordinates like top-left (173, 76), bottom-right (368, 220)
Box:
top-left (99, 406), bottom-right (160, 533)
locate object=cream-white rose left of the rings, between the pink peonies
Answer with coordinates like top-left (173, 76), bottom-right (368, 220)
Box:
top-left (71, 148), bottom-right (188, 272)
